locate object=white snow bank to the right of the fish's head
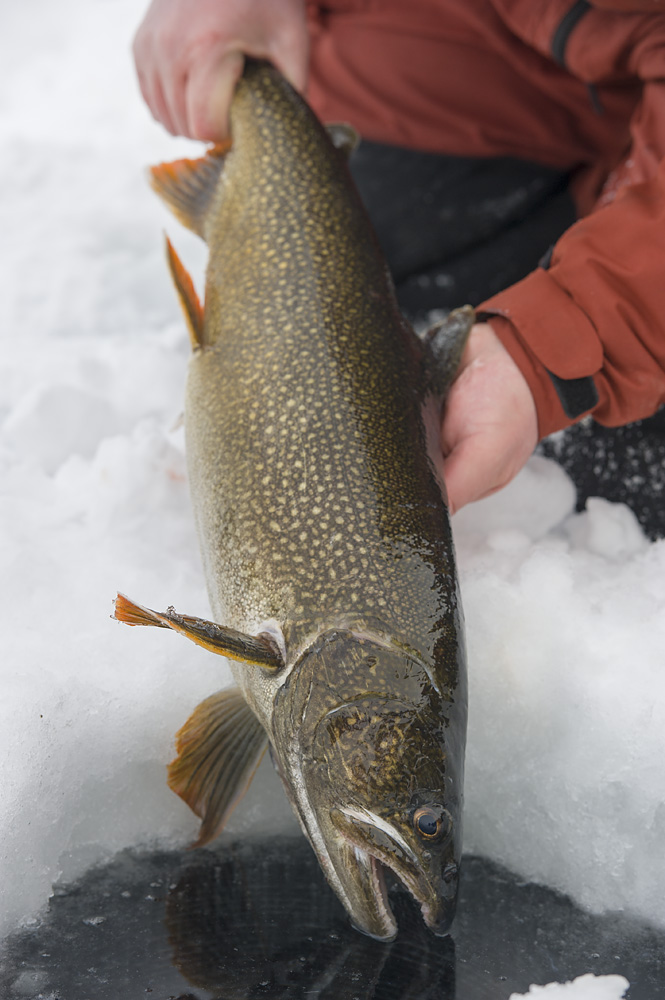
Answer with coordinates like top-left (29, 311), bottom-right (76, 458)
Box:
top-left (458, 460), bottom-right (665, 924)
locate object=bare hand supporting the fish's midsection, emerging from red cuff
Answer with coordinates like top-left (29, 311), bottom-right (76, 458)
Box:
top-left (441, 323), bottom-right (538, 514)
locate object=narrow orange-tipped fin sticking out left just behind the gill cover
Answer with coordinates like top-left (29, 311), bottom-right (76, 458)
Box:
top-left (113, 594), bottom-right (284, 670)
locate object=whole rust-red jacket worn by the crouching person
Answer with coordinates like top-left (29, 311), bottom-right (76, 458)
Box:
top-left (308, 0), bottom-right (665, 437)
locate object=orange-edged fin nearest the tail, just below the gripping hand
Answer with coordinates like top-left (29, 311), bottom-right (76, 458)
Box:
top-left (150, 142), bottom-right (231, 239)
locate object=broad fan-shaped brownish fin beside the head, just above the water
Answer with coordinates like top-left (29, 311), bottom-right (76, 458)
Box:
top-left (168, 688), bottom-right (268, 847)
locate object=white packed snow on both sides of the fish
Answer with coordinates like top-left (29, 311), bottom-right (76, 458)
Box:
top-left (0, 0), bottom-right (665, 984)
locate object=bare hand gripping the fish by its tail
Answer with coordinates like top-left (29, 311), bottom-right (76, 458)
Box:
top-left (134, 0), bottom-right (309, 142)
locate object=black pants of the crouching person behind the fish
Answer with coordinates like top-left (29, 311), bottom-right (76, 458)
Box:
top-left (350, 141), bottom-right (665, 538)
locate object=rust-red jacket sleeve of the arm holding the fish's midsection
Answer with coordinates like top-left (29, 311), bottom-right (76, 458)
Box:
top-left (479, 25), bottom-right (665, 437)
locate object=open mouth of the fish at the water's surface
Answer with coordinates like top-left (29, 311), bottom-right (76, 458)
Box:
top-left (331, 807), bottom-right (457, 941)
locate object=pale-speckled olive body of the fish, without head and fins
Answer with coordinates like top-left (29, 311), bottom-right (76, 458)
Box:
top-left (186, 62), bottom-right (458, 676)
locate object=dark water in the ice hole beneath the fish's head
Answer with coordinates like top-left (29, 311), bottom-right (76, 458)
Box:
top-left (0, 837), bottom-right (665, 1000)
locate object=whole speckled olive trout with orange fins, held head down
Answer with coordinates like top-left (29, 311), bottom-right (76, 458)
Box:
top-left (114, 59), bottom-right (474, 941)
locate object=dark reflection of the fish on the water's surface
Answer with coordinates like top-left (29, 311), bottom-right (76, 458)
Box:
top-left (166, 840), bottom-right (455, 1000)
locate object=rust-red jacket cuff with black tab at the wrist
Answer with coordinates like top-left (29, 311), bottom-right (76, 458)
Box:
top-left (478, 268), bottom-right (603, 438)
